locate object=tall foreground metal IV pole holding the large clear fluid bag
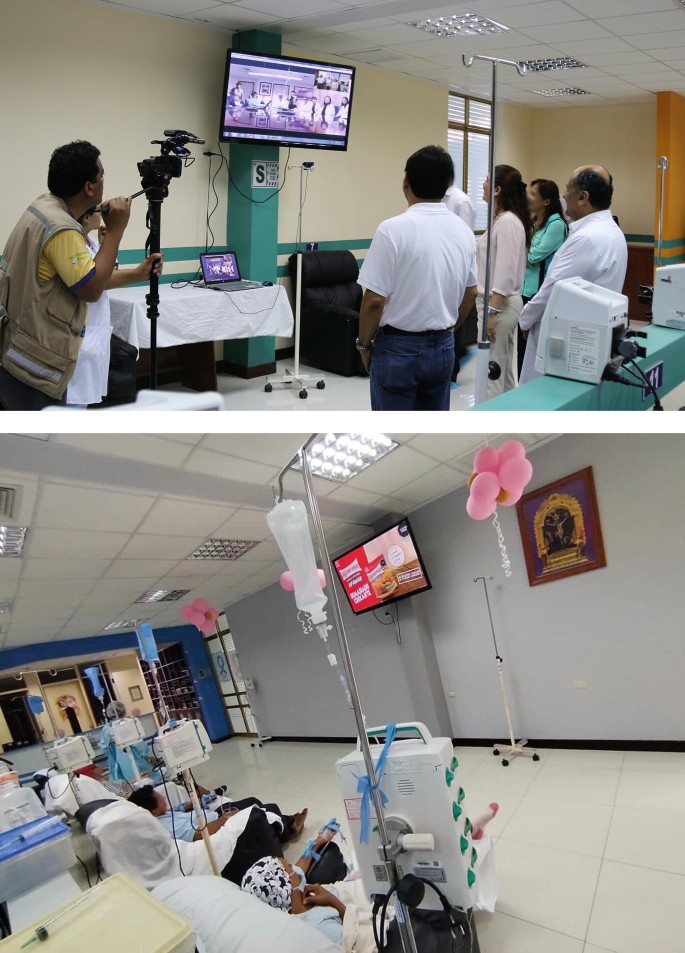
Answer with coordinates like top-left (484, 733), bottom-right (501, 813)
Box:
top-left (277, 434), bottom-right (418, 953)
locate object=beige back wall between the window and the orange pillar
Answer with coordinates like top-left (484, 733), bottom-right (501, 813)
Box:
top-left (497, 98), bottom-right (656, 235)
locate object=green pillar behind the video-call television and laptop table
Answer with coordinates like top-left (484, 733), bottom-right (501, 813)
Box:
top-left (224, 30), bottom-right (281, 378)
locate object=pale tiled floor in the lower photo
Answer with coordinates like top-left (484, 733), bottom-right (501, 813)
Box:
top-left (182, 739), bottom-right (685, 953)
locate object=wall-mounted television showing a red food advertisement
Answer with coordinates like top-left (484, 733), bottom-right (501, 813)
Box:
top-left (333, 519), bottom-right (431, 615)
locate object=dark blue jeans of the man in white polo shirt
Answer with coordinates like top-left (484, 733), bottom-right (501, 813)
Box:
top-left (370, 330), bottom-right (454, 410)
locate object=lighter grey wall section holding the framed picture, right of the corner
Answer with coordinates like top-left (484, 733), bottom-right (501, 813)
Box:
top-left (411, 434), bottom-right (685, 740)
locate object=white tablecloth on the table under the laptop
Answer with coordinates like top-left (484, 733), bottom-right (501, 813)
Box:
top-left (109, 284), bottom-right (293, 348)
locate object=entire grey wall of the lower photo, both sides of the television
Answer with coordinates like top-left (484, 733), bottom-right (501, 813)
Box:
top-left (226, 434), bottom-right (685, 740)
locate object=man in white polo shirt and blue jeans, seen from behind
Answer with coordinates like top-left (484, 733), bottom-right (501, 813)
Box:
top-left (357, 146), bottom-right (477, 410)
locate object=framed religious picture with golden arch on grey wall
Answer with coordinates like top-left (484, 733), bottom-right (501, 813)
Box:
top-left (516, 467), bottom-right (606, 586)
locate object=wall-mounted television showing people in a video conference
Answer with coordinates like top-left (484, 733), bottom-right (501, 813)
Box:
top-left (219, 50), bottom-right (354, 150)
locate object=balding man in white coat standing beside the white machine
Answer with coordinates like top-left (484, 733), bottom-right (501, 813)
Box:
top-left (519, 165), bottom-right (628, 384)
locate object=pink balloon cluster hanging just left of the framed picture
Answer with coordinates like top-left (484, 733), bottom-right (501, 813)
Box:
top-left (466, 440), bottom-right (533, 520)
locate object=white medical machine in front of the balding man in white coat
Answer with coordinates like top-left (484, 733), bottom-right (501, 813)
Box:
top-left (535, 278), bottom-right (628, 384)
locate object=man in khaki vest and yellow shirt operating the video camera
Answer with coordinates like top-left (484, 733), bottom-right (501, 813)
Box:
top-left (0, 141), bottom-right (136, 410)
